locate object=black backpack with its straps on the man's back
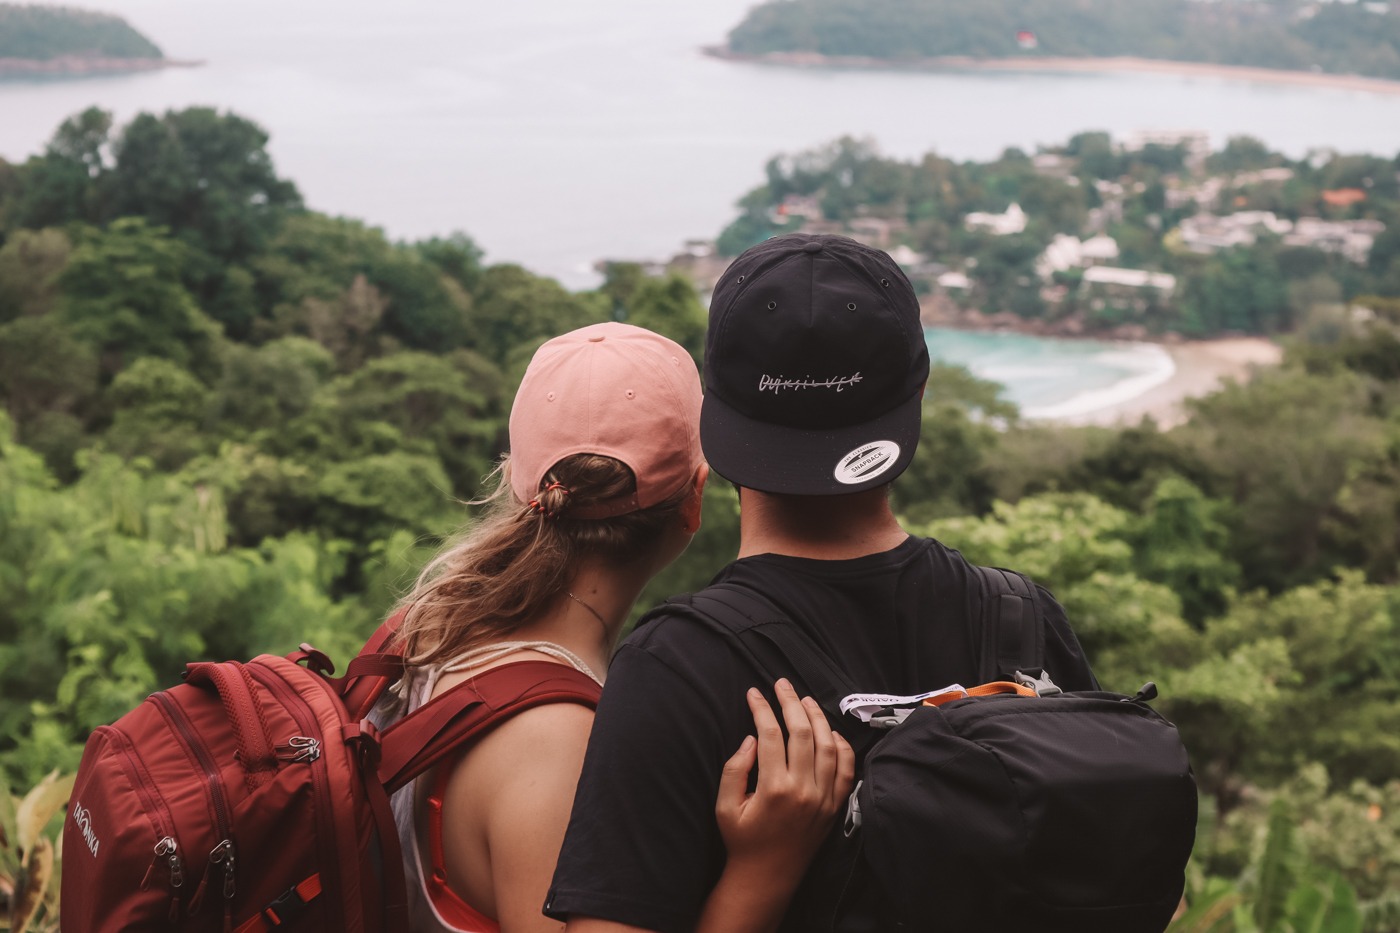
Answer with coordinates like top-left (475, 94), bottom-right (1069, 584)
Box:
top-left (661, 567), bottom-right (1197, 933)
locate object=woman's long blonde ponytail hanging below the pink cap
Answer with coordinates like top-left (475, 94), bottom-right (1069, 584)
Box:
top-left (399, 454), bottom-right (694, 667)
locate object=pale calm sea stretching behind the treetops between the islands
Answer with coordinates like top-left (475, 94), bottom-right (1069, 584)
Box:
top-left (0, 0), bottom-right (1400, 406)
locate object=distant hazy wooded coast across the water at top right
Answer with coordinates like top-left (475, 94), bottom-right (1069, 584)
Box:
top-left (715, 0), bottom-right (1400, 80)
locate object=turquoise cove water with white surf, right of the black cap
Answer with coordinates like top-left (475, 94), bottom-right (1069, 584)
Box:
top-left (924, 328), bottom-right (1176, 419)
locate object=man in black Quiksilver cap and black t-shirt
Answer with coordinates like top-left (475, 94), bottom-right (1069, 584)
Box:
top-left (546, 234), bottom-right (1096, 933)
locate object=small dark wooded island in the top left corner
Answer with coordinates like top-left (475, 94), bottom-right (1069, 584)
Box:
top-left (0, 3), bottom-right (197, 78)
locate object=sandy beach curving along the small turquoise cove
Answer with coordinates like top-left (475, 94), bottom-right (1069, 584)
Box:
top-left (1028, 336), bottom-right (1284, 430)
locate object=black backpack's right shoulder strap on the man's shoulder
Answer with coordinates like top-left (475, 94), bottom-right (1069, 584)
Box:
top-left (974, 567), bottom-right (1060, 693)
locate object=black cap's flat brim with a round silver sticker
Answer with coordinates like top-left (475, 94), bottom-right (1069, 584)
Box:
top-left (700, 389), bottom-right (924, 496)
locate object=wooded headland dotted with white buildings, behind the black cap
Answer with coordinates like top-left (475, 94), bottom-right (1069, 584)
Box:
top-left (688, 132), bottom-right (1400, 339)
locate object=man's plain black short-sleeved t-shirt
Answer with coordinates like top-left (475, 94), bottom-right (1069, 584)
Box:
top-left (545, 538), bottom-right (1096, 933)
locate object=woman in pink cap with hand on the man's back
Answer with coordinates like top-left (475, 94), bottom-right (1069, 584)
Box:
top-left (375, 324), bottom-right (854, 933)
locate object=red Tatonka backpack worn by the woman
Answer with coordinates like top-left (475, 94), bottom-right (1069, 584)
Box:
top-left (60, 616), bottom-right (599, 933)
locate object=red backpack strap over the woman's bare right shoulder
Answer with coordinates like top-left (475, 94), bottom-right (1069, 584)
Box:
top-left (379, 652), bottom-right (602, 794)
